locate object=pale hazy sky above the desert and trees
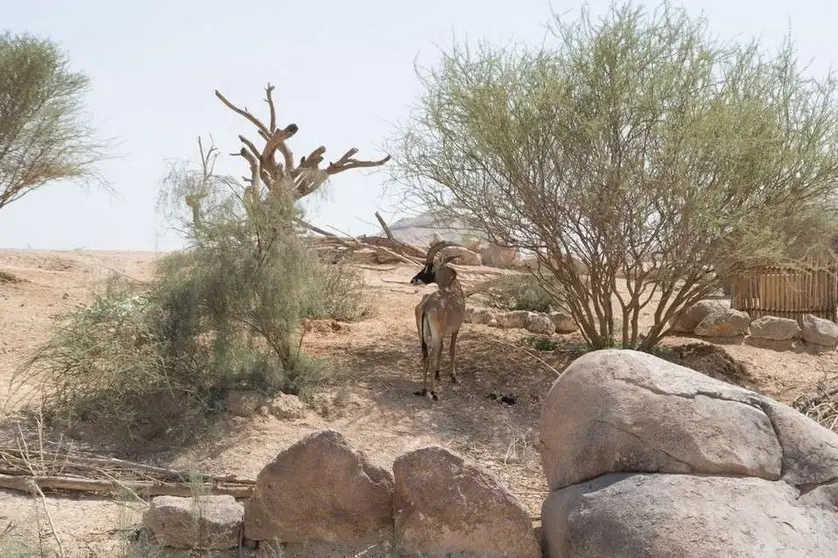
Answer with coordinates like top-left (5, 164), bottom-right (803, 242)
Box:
top-left (0, 0), bottom-right (838, 250)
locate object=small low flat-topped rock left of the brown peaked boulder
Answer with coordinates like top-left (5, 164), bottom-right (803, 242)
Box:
top-left (143, 495), bottom-right (244, 550)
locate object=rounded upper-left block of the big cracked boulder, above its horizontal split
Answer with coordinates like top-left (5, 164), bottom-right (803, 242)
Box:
top-left (540, 349), bottom-right (782, 490)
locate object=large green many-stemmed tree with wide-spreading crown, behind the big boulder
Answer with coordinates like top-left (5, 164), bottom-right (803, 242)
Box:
top-left (392, 4), bottom-right (838, 350)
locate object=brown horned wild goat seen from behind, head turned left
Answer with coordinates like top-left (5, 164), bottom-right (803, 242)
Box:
top-left (410, 241), bottom-right (466, 400)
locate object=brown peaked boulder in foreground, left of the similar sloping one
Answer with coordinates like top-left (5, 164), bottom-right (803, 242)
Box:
top-left (244, 430), bottom-right (393, 545)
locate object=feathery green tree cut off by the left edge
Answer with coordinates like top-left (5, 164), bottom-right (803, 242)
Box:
top-left (0, 32), bottom-right (105, 212)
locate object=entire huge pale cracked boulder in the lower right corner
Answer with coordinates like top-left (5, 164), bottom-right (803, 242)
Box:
top-left (539, 349), bottom-right (838, 558)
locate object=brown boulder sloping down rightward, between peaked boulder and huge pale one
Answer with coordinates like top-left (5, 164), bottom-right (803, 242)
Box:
top-left (393, 446), bottom-right (541, 558)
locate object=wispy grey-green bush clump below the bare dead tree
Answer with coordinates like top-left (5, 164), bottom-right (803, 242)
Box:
top-left (13, 143), bottom-right (354, 441)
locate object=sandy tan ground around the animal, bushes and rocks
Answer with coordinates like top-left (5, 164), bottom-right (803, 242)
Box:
top-left (0, 250), bottom-right (838, 556)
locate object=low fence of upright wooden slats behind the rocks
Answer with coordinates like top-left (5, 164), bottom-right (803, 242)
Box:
top-left (730, 260), bottom-right (838, 322)
